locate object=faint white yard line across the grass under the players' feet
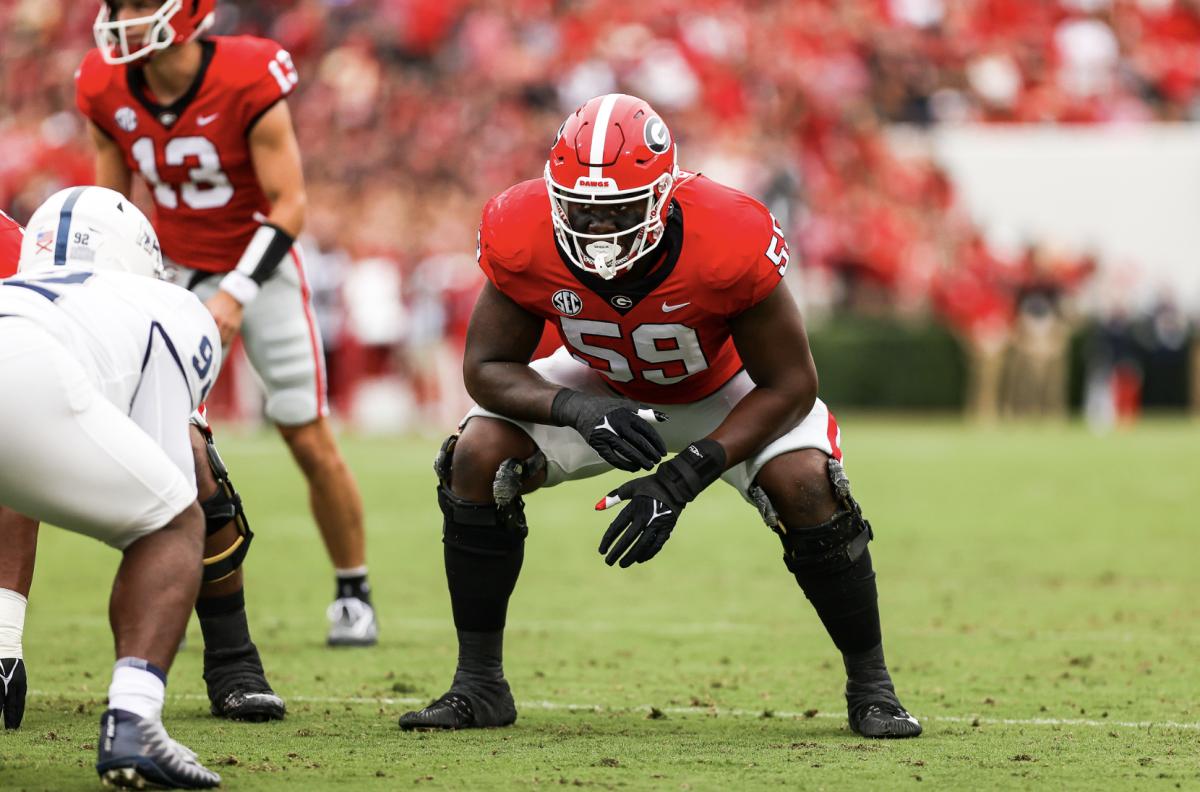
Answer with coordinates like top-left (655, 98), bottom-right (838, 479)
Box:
top-left (29, 690), bottom-right (1200, 731)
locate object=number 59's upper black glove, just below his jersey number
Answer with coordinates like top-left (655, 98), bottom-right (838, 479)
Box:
top-left (550, 388), bottom-right (667, 472)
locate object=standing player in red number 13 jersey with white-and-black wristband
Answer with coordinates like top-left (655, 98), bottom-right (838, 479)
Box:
top-left (76, 0), bottom-right (377, 646)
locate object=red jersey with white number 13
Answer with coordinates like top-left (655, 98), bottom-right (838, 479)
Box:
top-left (76, 36), bottom-right (299, 272)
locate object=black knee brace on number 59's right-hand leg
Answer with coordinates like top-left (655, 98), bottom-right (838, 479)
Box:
top-left (750, 457), bottom-right (875, 577)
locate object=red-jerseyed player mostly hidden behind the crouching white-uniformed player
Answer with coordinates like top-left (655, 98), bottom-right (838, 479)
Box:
top-left (0, 211), bottom-right (287, 728)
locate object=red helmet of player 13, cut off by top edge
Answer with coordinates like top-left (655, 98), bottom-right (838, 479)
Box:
top-left (91, 0), bottom-right (217, 65)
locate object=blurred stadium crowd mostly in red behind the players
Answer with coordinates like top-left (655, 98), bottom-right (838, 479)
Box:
top-left (0, 0), bottom-right (1200, 421)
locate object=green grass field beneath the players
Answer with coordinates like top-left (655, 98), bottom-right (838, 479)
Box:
top-left (0, 418), bottom-right (1200, 791)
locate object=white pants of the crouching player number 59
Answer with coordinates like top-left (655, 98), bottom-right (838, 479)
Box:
top-left (460, 347), bottom-right (841, 497)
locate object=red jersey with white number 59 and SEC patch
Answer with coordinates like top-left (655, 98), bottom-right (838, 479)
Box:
top-left (479, 175), bottom-right (788, 404)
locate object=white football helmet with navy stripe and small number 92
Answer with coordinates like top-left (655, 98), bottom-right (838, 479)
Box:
top-left (17, 187), bottom-right (163, 277)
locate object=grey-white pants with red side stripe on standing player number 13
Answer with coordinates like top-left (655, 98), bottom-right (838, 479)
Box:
top-left (172, 245), bottom-right (329, 426)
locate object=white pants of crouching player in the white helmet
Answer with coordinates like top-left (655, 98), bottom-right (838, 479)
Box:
top-left (0, 317), bottom-right (196, 552)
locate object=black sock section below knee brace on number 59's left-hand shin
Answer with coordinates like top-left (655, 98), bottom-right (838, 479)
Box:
top-left (443, 545), bottom-right (524, 635)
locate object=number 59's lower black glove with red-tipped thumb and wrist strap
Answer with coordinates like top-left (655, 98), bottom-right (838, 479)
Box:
top-left (596, 439), bottom-right (725, 569)
